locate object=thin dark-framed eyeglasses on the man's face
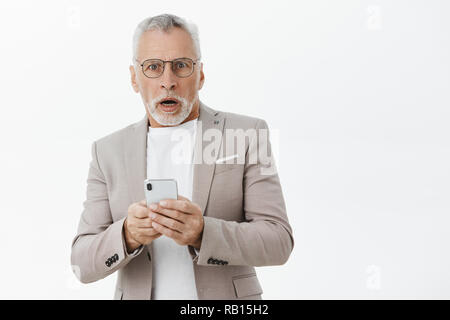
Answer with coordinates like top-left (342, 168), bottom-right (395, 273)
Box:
top-left (136, 58), bottom-right (200, 78)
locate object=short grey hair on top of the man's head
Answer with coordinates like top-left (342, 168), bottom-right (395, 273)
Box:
top-left (132, 14), bottom-right (201, 65)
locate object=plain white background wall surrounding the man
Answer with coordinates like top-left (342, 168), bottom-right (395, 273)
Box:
top-left (0, 0), bottom-right (450, 299)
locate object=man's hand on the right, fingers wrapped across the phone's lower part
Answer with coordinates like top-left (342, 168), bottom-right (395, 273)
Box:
top-left (149, 195), bottom-right (204, 250)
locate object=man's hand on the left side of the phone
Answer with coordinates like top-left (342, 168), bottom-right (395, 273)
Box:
top-left (123, 200), bottom-right (162, 253)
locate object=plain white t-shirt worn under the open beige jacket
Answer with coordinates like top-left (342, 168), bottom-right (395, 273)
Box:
top-left (147, 119), bottom-right (198, 300)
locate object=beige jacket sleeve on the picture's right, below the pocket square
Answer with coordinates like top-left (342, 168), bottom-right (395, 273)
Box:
top-left (197, 120), bottom-right (294, 266)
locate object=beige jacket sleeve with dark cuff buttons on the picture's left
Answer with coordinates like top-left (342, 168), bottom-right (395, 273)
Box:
top-left (71, 142), bottom-right (143, 283)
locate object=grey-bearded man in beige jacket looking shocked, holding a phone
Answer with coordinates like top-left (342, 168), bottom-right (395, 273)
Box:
top-left (71, 14), bottom-right (294, 300)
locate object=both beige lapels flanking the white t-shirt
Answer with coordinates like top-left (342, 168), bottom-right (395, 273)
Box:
top-left (123, 101), bottom-right (224, 213)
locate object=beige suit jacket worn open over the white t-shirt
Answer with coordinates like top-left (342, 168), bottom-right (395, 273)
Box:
top-left (71, 102), bottom-right (294, 300)
